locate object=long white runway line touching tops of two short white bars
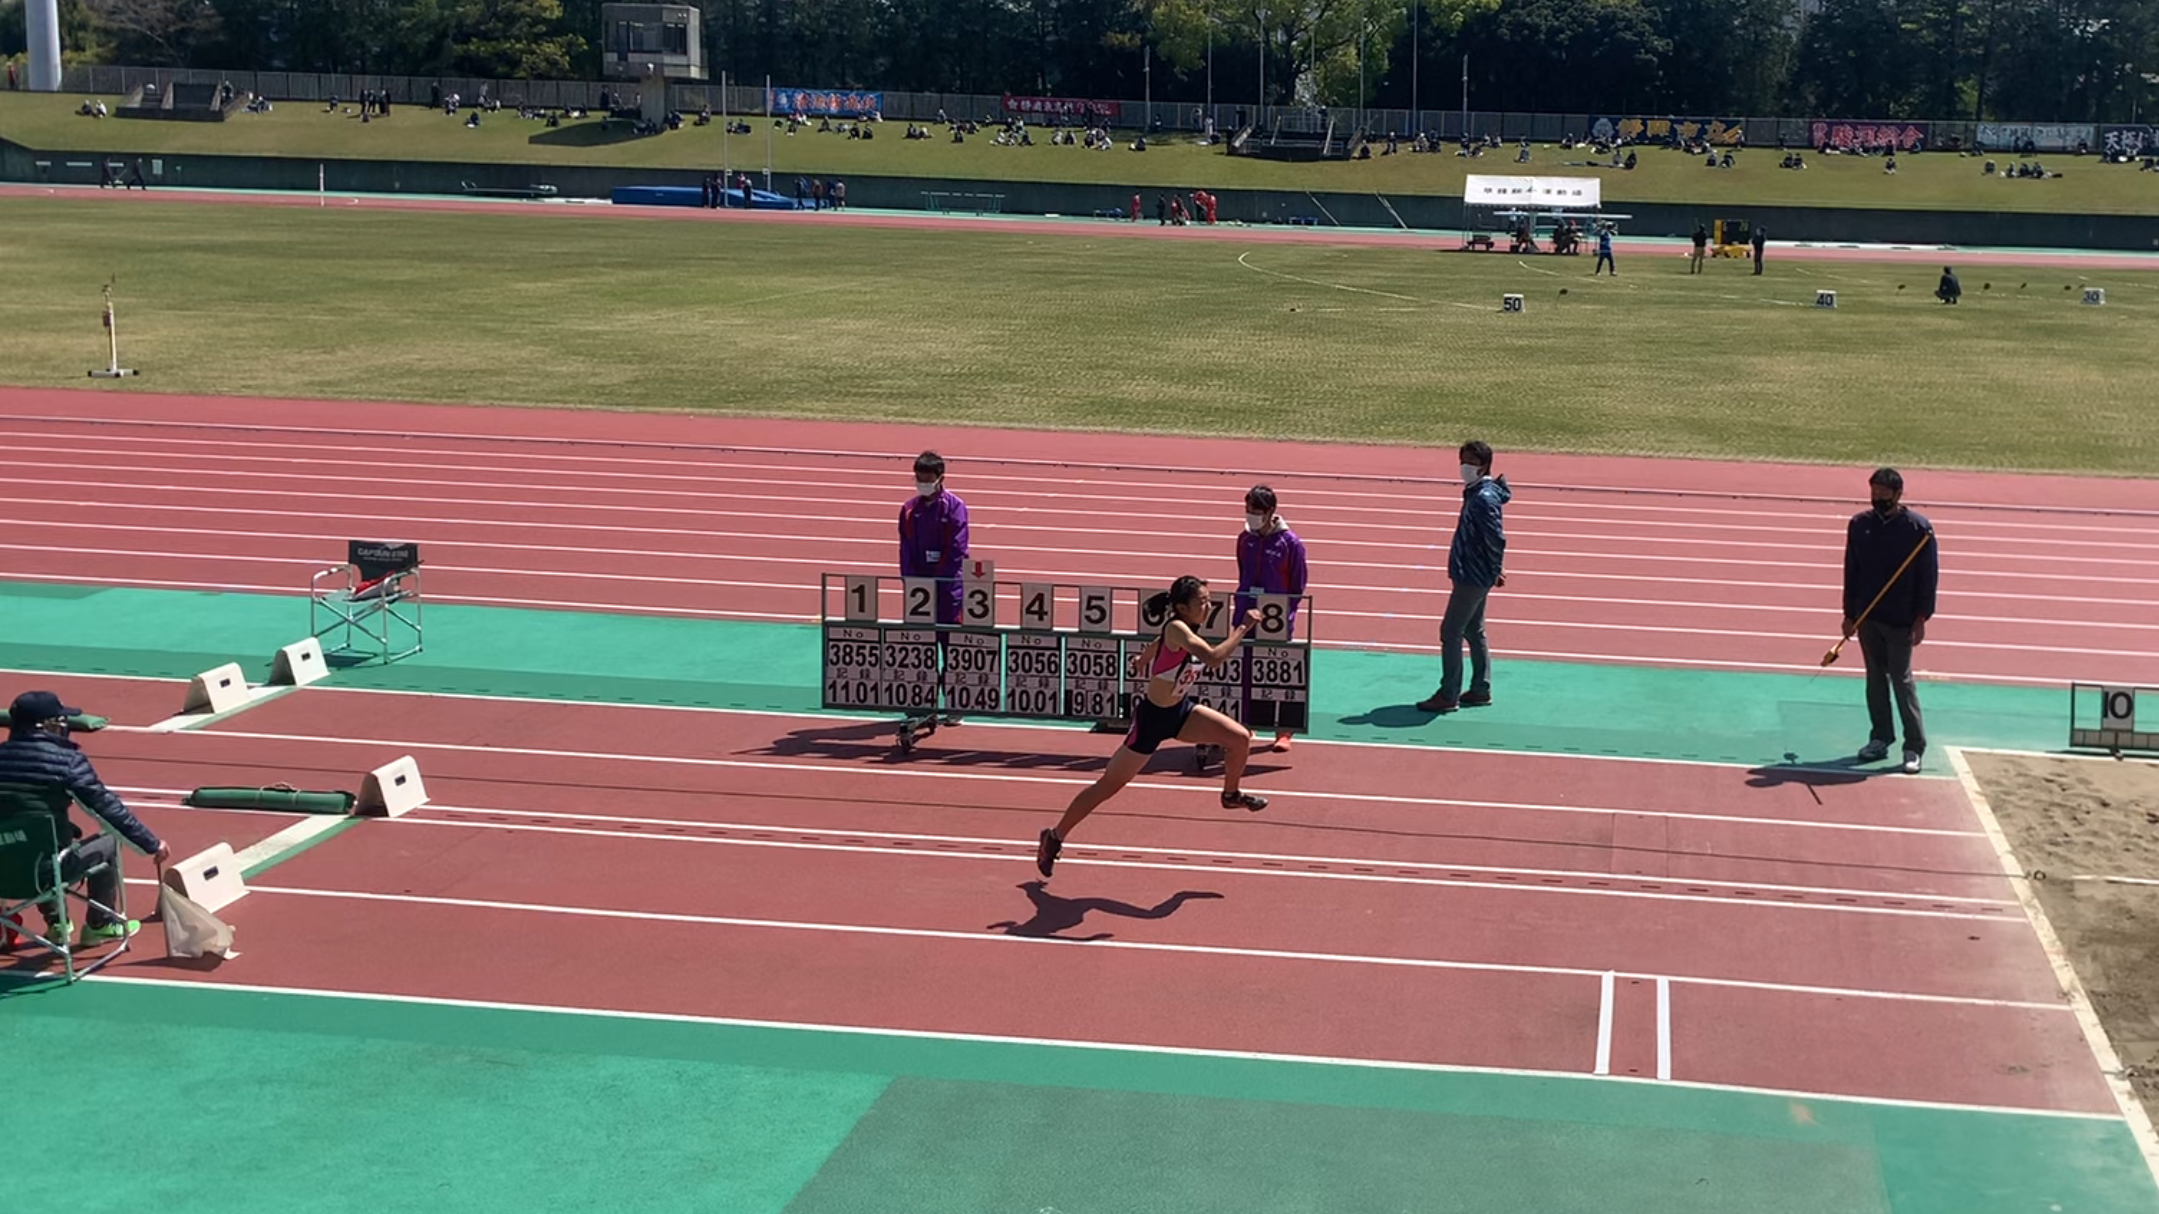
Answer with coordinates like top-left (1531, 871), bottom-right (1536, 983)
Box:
top-left (227, 886), bottom-right (2068, 1011)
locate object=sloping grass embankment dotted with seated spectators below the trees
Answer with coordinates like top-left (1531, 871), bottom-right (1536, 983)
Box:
top-left (0, 93), bottom-right (2159, 214)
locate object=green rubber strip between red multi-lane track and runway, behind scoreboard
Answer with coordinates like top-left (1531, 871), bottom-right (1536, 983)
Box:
top-left (0, 583), bottom-right (2068, 765)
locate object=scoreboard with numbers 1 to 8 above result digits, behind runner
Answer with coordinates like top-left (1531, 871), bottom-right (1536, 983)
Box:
top-left (820, 562), bottom-right (1313, 747)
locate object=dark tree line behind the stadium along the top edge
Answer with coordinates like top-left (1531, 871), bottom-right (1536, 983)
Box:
top-left (0, 0), bottom-right (2159, 121)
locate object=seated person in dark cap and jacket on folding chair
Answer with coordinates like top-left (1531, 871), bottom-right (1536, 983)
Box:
top-left (0, 691), bottom-right (171, 944)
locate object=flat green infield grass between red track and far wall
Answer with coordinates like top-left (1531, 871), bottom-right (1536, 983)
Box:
top-left (0, 199), bottom-right (2159, 475)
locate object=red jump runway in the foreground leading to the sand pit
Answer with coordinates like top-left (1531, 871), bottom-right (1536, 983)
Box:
top-left (50, 689), bottom-right (2112, 1112)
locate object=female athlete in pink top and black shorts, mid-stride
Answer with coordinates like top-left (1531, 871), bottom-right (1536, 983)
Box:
top-left (1034, 575), bottom-right (1267, 879)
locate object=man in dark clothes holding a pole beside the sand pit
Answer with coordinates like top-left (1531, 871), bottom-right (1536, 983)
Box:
top-left (1844, 469), bottom-right (1941, 773)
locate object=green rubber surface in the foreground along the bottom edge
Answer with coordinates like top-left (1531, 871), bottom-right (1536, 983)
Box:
top-left (0, 961), bottom-right (2159, 1214)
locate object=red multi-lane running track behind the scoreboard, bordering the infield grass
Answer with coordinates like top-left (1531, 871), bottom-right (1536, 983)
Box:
top-left (0, 389), bottom-right (2159, 685)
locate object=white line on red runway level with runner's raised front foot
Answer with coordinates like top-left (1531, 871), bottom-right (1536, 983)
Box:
top-left (143, 730), bottom-right (1980, 838)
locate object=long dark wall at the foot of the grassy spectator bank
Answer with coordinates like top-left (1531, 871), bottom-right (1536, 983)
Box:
top-left (0, 140), bottom-right (2159, 251)
